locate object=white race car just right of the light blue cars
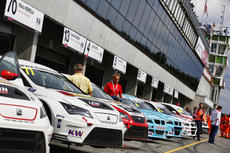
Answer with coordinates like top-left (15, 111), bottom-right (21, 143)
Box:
top-left (161, 103), bottom-right (197, 136)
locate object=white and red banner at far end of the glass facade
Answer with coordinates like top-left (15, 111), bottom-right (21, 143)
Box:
top-left (195, 37), bottom-right (208, 66)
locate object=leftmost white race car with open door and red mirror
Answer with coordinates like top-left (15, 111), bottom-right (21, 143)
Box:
top-left (0, 52), bottom-right (53, 153)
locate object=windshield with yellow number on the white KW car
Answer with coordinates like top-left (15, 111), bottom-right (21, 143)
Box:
top-left (22, 68), bottom-right (83, 94)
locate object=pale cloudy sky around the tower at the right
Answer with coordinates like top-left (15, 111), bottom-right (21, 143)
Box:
top-left (192, 0), bottom-right (230, 113)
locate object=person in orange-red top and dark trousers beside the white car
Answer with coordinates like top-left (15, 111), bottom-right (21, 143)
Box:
top-left (194, 103), bottom-right (204, 141)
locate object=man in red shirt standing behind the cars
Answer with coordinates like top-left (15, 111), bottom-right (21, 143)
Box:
top-left (104, 73), bottom-right (122, 100)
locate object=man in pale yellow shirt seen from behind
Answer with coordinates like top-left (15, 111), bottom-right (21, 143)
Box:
top-left (69, 64), bottom-right (93, 96)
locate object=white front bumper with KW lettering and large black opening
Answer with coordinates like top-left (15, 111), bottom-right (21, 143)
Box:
top-left (53, 115), bottom-right (126, 147)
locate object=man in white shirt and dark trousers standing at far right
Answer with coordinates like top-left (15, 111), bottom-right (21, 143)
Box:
top-left (208, 105), bottom-right (222, 144)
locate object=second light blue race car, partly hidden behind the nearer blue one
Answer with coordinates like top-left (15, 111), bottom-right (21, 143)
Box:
top-left (145, 100), bottom-right (183, 137)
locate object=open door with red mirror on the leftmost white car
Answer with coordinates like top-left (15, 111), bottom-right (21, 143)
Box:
top-left (0, 51), bottom-right (22, 85)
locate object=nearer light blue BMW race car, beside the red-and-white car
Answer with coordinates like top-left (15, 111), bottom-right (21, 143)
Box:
top-left (121, 94), bottom-right (173, 139)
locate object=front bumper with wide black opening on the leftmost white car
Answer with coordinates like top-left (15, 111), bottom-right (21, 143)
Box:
top-left (0, 119), bottom-right (53, 153)
